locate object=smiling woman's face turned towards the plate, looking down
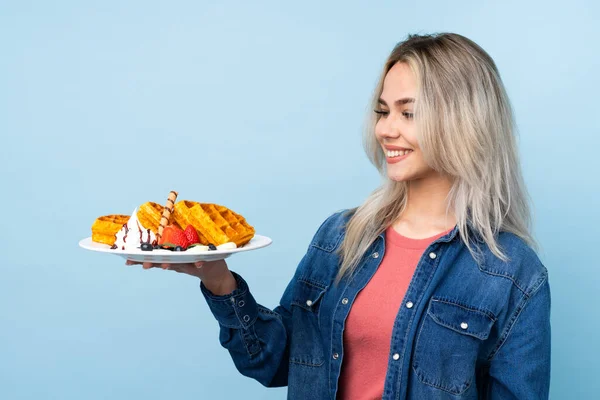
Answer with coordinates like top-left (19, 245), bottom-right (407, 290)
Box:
top-left (375, 63), bottom-right (434, 181)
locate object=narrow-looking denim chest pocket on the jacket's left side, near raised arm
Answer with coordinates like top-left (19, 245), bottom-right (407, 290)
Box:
top-left (290, 278), bottom-right (327, 367)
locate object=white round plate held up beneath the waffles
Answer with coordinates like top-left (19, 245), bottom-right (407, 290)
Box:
top-left (79, 235), bottom-right (273, 264)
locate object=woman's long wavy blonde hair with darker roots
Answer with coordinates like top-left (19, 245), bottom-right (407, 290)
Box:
top-left (337, 33), bottom-right (536, 281)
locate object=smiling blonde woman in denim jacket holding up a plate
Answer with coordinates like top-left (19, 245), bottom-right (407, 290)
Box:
top-left (129, 34), bottom-right (550, 400)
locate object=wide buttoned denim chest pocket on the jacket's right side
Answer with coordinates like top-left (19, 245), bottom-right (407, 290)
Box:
top-left (413, 298), bottom-right (496, 395)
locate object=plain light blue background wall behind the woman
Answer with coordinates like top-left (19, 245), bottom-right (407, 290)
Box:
top-left (0, 1), bottom-right (600, 399)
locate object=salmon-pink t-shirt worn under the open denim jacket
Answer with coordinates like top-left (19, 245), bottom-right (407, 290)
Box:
top-left (338, 227), bottom-right (450, 400)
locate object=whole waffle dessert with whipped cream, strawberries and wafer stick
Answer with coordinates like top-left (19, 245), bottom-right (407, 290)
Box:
top-left (92, 191), bottom-right (255, 252)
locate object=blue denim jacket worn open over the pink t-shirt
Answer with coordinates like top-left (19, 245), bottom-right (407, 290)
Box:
top-left (201, 212), bottom-right (550, 400)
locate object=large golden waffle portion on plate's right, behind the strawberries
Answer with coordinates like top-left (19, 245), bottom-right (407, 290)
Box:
top-left (172, 200), bottom-right (255, 247)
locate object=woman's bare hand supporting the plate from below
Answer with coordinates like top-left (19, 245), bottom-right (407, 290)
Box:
top-left (125, 260), bottom-right (237, 296)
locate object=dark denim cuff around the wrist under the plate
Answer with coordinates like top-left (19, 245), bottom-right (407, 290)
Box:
top-left (200, 271), bottom-right (258, 329)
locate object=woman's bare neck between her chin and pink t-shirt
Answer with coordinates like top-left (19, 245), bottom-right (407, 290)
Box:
top-left (393, 174), bottom-right (456, 238)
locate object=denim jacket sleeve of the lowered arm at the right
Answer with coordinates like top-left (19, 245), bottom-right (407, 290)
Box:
top-left (488, 272), bottom-right (551, 400)
